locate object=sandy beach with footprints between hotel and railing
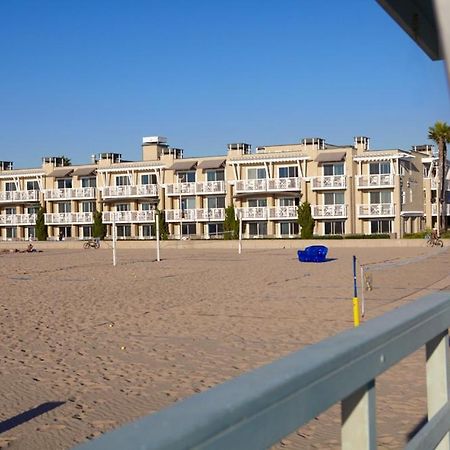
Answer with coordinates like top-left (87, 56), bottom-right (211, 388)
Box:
top-left (0, 244), bottom-right (450, 449)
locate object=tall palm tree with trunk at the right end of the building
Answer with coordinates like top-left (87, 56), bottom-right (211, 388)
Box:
top-left (428, 121), bottom-right (450, 229)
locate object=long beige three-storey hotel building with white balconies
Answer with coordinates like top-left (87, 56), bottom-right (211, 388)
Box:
top-left (0, 136), bottom-right (450, 240)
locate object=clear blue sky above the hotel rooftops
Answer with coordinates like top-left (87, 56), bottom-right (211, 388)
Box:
top-left (0, 0), bottom-right (450, 168)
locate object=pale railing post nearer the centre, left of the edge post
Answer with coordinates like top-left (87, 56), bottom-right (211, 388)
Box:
top-left (341, 380), bottom-right (376, 450)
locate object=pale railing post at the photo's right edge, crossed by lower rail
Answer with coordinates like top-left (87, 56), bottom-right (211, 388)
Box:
top-left (426, 330), bottom-right (450, 450)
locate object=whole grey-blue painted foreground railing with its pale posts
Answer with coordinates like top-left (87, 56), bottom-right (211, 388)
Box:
top-left (77, 292), bottom-right (450, 450)
